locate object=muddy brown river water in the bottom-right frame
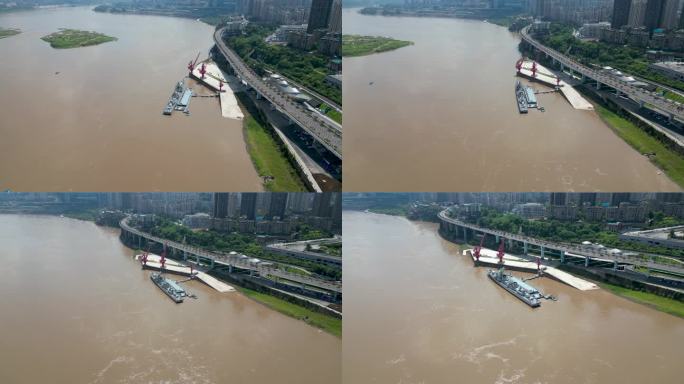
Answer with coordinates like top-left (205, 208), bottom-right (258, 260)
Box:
top-left (343, 211), bottom-right (684, 384)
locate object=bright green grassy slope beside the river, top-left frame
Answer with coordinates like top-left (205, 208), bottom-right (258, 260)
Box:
top-left (244, 116), bottom-right (306, 192)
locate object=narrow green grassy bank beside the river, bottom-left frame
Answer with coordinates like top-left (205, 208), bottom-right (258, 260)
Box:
top-left (237, 287), bottom-right (342, 337)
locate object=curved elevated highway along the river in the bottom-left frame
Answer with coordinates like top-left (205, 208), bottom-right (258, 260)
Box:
top-left (119, 217), bottom-right (342, 293)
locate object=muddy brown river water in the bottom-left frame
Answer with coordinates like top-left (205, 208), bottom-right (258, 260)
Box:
top-left (0, 215), bottom-right (342, 384)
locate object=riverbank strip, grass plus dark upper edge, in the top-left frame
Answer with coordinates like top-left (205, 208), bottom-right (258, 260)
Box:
top-left (235, 92), bottom-right (307, 192)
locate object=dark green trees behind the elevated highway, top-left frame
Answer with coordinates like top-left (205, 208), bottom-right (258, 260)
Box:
top-left (226, 23), bottom-right (342, 104)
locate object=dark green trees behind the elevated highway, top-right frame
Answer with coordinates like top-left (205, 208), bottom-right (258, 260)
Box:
top-left (537, 23), bottom-right (684, 91)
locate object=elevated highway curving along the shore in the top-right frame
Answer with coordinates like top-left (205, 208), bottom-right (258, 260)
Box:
top-left (520, 26), bottom-right (684, 121)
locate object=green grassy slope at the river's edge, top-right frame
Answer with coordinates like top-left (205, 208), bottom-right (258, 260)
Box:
top-left (596, 105), bottom-right (684, 187)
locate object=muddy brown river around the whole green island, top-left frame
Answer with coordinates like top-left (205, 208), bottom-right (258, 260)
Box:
top-left (0, 7), bottom-right (262, 191)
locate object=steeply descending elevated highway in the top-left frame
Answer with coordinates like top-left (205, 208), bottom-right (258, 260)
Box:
top-left (214, 28), bottom-right (342, 159)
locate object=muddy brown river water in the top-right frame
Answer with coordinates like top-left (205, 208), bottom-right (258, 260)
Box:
top-left (343, 9), bottom-right (679, 192)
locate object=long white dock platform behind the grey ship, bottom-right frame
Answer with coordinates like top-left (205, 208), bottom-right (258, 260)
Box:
top-left (463, 248), bottom-right (599, 291)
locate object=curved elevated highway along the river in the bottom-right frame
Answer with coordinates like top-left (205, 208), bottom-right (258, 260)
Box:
top-left (439, 210), bottom-right (684, 273)
